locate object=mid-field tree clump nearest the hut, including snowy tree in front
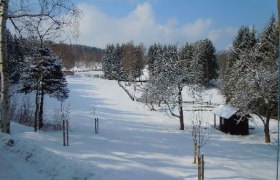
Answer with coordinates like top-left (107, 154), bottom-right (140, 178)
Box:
top-left (142, 39), bottom-right (218, 130)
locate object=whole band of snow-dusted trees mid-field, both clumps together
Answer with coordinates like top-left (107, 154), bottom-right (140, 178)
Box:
top-left (102, 39), bottom-right (218, 130)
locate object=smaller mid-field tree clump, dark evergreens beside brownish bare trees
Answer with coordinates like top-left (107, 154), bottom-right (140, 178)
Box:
top-left (102, 42), bottom-right (146, 81)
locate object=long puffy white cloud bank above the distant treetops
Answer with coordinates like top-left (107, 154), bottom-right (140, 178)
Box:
top-left (76, 2), bottom-right (236, 48)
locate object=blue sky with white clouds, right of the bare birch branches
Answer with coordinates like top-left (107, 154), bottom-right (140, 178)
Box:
top-left (74, 0), bottom-right (277, 50)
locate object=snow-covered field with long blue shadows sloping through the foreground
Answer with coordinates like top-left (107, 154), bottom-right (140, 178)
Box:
top-left (0, 73), bottom-right (277, 180)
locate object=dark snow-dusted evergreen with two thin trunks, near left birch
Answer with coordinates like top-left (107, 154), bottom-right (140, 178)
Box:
top-left (21, 47), bottom-right (69, 131)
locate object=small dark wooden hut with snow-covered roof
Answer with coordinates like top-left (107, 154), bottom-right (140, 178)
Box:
top-left (212, 105), bottom-right (250, 135)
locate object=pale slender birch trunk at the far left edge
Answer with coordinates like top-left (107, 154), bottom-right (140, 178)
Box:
top-left (0, 0), bottom-right (10, 133)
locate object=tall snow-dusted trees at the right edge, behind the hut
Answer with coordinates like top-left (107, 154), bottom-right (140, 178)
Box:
top-left (222, 16), bottom-right (279, 143)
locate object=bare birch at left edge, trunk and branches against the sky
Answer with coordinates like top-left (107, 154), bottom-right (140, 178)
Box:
top-left (0, 0), bottom-right (80, 133)
